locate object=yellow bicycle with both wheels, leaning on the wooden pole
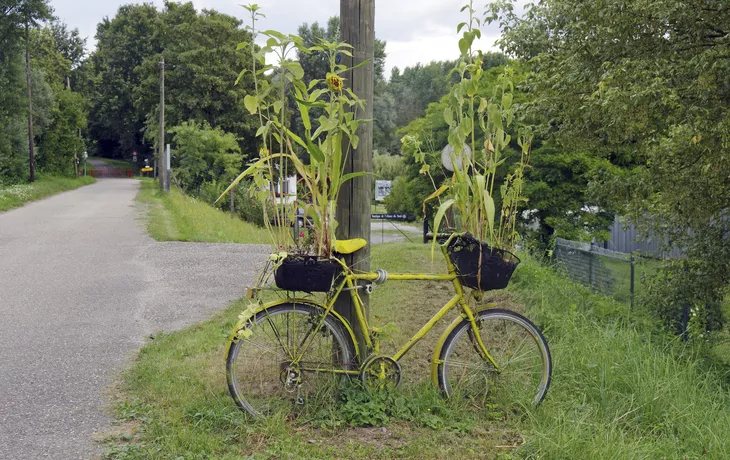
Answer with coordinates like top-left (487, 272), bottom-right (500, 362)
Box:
top-left (226, 233), bottom-right (552, 416)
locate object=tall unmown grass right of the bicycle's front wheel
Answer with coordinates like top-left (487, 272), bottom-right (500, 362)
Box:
top-left (513, 263), bottom-right (730, 459)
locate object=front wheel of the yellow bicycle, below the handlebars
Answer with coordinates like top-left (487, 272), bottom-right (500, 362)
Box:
top-left (438, 309), bottom-right (552, 410)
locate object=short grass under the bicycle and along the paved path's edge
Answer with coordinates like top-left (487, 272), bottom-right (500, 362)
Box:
top-left (107, 244), bottom-right (520, 459)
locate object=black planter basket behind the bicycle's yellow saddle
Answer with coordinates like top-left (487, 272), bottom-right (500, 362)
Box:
top-left (274, 256), bottom-right (342, 292)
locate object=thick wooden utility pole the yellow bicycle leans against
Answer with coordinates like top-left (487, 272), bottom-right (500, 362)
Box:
top-left (335, 0), bottom-right (375, 359)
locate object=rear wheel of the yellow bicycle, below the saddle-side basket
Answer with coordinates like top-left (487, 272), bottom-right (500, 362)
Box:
top-left (226, 303), bottom-right (356, 416)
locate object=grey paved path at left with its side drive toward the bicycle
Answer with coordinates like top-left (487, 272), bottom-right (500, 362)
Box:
top-left (0, 179), bottom-right (268, 459)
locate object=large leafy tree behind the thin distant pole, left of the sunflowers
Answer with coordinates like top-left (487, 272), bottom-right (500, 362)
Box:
top-left (134, 2), bottom-right (258, 158)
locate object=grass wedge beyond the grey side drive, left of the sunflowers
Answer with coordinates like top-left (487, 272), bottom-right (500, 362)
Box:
top-left (137, 179), bottom-right (271, 244)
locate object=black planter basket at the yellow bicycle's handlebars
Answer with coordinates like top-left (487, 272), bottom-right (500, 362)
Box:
top-left (448, 234), bottom-right (520, 291)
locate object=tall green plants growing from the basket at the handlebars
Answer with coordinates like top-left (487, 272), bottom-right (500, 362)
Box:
top-left (424, 1), bottom-right (532, 250)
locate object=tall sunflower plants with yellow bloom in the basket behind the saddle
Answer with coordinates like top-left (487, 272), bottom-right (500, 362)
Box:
top-left (215, 4), bottom-right (367, 257)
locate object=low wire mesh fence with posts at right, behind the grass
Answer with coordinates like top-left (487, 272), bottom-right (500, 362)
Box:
top-left (554, 238), bottom-right (660, 308)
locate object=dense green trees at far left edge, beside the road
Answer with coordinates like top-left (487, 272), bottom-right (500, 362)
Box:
top-left (0, 0), bottom-right (86, 184)
